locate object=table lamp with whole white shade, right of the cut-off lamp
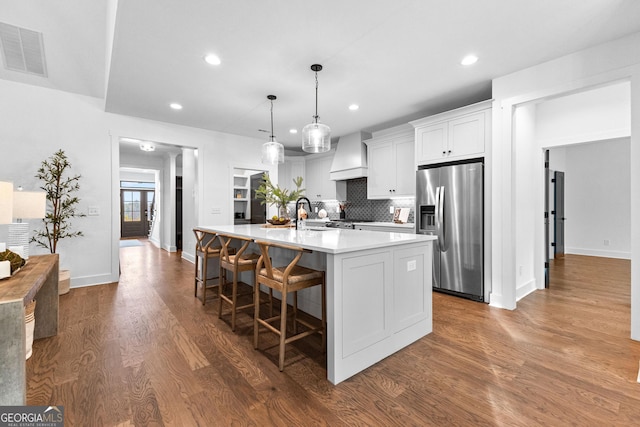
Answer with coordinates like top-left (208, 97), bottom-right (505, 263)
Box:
top-left (7, 191), bottom-right (47, 259)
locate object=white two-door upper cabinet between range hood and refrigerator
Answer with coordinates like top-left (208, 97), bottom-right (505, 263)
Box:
top-left (365, 125), bottom-right (416, 199)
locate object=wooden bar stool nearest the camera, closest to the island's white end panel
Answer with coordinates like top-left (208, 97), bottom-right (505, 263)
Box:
top-left (253, 240), bottom-right (327, 371)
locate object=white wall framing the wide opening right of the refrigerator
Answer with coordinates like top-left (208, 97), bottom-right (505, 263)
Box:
top-left (491, 33), bottom-right (640, 339)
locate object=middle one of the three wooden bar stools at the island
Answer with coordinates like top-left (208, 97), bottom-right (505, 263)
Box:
top-left (218, 234), bottom-right (260, 331)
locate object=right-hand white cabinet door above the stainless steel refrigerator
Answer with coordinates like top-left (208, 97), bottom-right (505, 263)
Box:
top-left (449, 112), bottom-right (485, 157)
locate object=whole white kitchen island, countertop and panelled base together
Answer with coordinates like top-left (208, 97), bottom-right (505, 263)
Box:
top-left (197, 224), bottom-right (434, 384)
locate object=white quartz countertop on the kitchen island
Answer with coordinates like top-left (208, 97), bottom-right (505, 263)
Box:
top-left (197, 223), bottom-right (435, 254)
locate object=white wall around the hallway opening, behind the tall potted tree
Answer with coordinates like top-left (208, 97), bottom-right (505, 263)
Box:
top-left (0, 80), bottom-right (277, 287)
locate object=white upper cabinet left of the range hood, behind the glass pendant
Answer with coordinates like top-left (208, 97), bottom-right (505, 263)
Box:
top-left (304, 150), bottom-right (347, 201)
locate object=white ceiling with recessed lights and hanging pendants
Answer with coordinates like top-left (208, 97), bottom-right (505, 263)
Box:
top-left (0, 0), bottom-right (640, 152)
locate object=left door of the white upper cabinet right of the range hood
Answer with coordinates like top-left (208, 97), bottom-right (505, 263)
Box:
top-left (367, 141), bottom-right (395, 199)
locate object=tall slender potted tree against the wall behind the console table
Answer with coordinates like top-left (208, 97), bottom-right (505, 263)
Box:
top-left (31, 150), bottom-right (85, 295)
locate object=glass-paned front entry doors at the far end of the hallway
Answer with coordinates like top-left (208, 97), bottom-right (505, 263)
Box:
top-left (120, 190), bottom-right (154, 237)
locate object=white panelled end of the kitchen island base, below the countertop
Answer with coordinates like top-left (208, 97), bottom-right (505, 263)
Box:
top-left (327, 242), bottom-right (433, 384)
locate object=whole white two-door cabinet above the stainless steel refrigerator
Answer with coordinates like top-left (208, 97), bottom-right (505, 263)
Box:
top-left (411, 100), bottom-right (491, 165)
